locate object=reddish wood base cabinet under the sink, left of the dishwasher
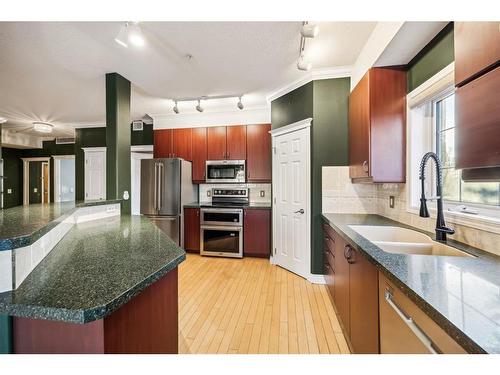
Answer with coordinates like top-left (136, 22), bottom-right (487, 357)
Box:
top-left (324, 225), bottom-right (380, 354)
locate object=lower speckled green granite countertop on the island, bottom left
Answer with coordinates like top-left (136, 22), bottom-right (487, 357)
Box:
top-left (0, 215), bottom-right (186, 323)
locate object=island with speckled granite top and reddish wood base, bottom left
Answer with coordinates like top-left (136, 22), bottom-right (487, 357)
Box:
top-left (0, 201), bottom-right (185, 353)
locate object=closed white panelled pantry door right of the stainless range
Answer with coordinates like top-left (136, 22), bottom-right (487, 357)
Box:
top-left (273, 124), bottom-right (311, 278)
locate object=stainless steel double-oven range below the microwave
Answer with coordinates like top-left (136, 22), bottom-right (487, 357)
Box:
top-left (200, 188), bottom-right (249, 258)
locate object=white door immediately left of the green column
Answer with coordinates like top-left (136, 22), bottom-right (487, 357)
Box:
top-left (82, 147), bottom-right (106, 200)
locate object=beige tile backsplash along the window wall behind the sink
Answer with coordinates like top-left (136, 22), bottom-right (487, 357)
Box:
top-left (322, 167), bottom-right (500, 255)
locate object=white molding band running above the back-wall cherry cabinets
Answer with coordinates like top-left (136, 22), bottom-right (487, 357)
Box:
top-left (149, 105), bottom-right (271, 129)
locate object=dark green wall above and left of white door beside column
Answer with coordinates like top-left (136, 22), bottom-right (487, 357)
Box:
top-left (74, 127), bottom-right (106, 201)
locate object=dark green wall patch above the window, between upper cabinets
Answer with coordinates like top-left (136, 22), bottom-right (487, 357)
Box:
top-left (406, 23), bottom-right (455, 92)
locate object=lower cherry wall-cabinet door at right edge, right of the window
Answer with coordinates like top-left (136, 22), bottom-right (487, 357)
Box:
top-left (455, 67), bottom-right (500, 169)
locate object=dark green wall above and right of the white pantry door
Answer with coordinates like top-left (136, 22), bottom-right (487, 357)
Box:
top-left (271, 78), bottom-right (350, 274)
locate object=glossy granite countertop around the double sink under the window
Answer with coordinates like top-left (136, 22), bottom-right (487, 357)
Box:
top-left (323, 214), bottom-right (500, 353)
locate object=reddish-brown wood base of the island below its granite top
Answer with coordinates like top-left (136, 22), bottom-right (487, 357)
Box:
top-left (13, 268), bottom-right (179, 354)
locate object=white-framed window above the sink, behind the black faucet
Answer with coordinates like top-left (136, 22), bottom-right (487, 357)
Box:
top-left (433, 93), bottom-right (500, 207)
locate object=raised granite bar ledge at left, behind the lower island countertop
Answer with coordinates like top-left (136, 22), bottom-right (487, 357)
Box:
top-left (0, 199), bottom-right (121, 251)
